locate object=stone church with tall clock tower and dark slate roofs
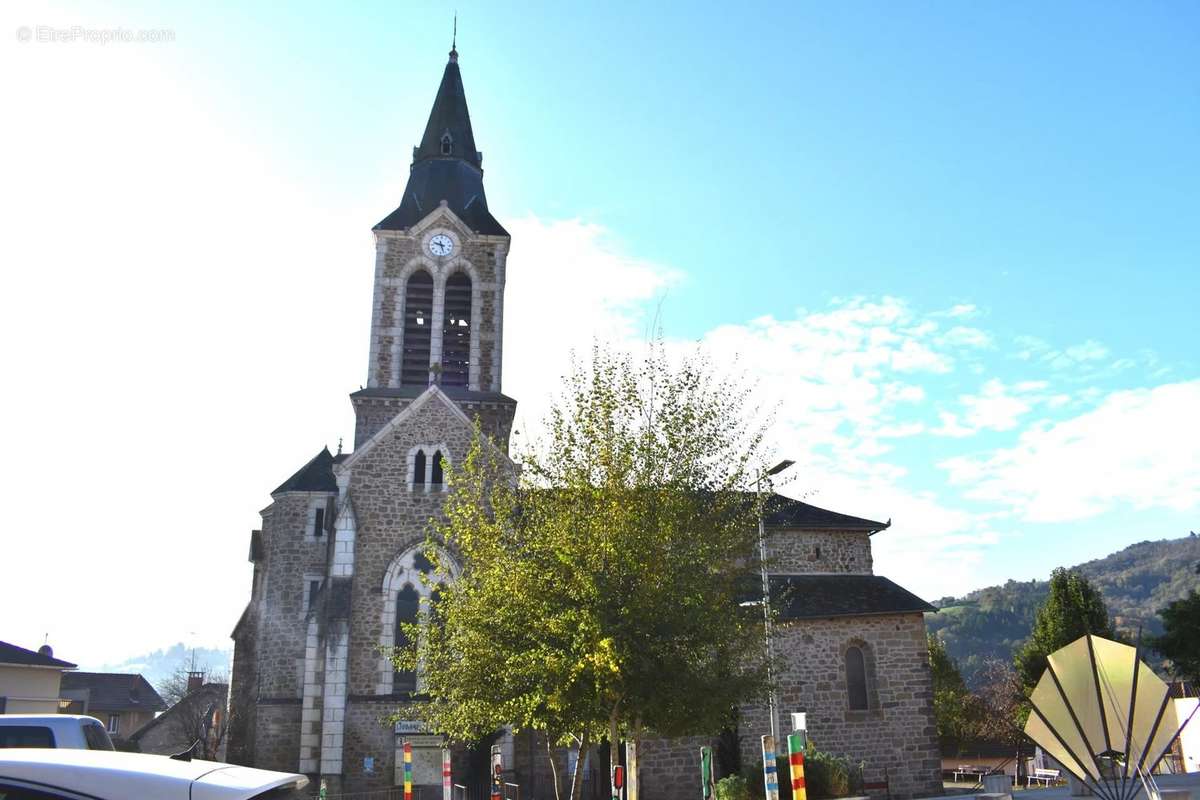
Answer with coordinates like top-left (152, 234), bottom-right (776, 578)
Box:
top-left (228, 42), bottom-right (942, 800)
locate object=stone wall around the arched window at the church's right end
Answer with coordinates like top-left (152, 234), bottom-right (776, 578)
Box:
top-left (740, 614), bottom-right (942, 798)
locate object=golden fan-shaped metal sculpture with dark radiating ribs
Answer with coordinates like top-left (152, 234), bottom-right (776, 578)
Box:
top-left (1025, 636), bottom-right (1190, 800)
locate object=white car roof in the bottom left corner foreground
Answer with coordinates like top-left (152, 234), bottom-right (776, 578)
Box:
top-left (0, 748), bottom-right (308, 800)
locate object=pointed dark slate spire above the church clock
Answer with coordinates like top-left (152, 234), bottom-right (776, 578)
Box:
top-left (376, 46), bottom-right (508, 236)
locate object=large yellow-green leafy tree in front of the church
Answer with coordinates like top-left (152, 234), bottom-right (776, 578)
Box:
top-left (397, 345), bottom-right (766, 800)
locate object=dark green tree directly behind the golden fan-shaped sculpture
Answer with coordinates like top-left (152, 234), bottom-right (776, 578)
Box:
top-left (1014, 567), bottom-right (1115, 691)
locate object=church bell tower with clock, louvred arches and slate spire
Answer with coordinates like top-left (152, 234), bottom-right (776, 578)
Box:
top-left (350, 48), bottom-right (516, 447)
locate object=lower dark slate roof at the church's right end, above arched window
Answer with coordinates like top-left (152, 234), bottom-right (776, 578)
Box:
top-left (770, 575), bottom-right (937, 621)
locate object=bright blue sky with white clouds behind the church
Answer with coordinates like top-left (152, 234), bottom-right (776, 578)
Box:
top-left (0, 2), bottom-right (1200, 660)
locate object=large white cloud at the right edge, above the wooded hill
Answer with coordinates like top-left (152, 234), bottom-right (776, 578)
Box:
top-left (940, 380), bottom-right (1200, 522)
